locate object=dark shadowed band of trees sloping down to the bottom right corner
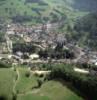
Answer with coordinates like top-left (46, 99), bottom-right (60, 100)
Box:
top-left (48, 64), bottom-right (97, 100)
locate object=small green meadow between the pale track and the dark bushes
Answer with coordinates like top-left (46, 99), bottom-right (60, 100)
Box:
top-left (16, 68), bottom-right (37, 93)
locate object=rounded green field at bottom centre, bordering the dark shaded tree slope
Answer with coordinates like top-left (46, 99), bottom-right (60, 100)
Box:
top-left (18, 81), bottom-right (83, 100)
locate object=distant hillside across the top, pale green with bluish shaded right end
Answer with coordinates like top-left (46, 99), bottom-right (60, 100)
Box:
top-left (0, 0), bottom-right (94, 23)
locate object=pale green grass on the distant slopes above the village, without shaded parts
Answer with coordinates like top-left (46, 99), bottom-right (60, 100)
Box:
top-left (0, 0), bottom-right (86, 23)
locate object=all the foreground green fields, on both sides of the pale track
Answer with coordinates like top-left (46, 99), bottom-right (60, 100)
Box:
top-left (0, 68), bottom-right (83, 100)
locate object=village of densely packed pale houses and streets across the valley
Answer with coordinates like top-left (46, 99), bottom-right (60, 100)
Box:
top-left (0, 23), bottom-right (97, 65)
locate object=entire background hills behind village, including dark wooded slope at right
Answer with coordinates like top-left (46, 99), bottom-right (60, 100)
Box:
top-left (0, 0), bottom-right (97, 47)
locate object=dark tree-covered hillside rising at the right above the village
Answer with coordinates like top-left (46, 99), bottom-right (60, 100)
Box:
top-left (73, 13), bottom-right (97, 49)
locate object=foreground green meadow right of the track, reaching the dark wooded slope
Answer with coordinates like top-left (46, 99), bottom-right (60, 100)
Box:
top-left (16, 68), bottom-right (83, 100)
